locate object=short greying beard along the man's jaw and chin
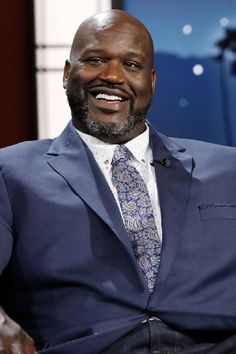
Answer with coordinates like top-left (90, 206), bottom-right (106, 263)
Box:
top-left (66, 90), bottom-right (152, 140)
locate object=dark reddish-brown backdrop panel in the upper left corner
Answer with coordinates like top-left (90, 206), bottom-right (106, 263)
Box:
top-left (0, 0), bottom-right (37, 147)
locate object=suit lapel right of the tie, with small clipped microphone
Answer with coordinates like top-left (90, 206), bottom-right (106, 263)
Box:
top-left (151, 128), bottom-right (193, 289)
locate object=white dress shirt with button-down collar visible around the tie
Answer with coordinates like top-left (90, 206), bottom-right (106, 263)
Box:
top-left (76, 125), bottom-right (162, 240)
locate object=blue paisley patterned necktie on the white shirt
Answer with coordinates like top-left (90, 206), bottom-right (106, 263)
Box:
top-left (112, 145), bottom-right (161, 292)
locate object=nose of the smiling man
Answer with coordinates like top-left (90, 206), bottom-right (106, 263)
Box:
top-left (100, 61), bottom-right (124, 84)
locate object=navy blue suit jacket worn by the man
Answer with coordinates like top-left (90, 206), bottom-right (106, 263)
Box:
top-left (0, 123), bottom-right (236, 354)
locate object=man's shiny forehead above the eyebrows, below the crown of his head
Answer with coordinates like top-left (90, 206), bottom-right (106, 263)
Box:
top-left (73, 21), bottom-right (152, 57)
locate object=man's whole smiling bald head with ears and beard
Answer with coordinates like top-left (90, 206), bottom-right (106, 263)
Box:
top-left (64, 11), bottom-right (155, 143)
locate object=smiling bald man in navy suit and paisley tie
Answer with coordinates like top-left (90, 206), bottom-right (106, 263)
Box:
top-left (0, 10), bottom-right (236, 354)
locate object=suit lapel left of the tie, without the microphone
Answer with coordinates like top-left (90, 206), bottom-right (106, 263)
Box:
top-left (45, 123), bottom-right (133, 255)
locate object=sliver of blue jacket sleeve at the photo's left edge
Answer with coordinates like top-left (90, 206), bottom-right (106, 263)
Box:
top-left (0, 173), bottom-right (13, 274)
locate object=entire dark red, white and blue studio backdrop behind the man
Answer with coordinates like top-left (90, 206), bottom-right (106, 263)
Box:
top-left (0, 0), bottom-right (236, 147)
